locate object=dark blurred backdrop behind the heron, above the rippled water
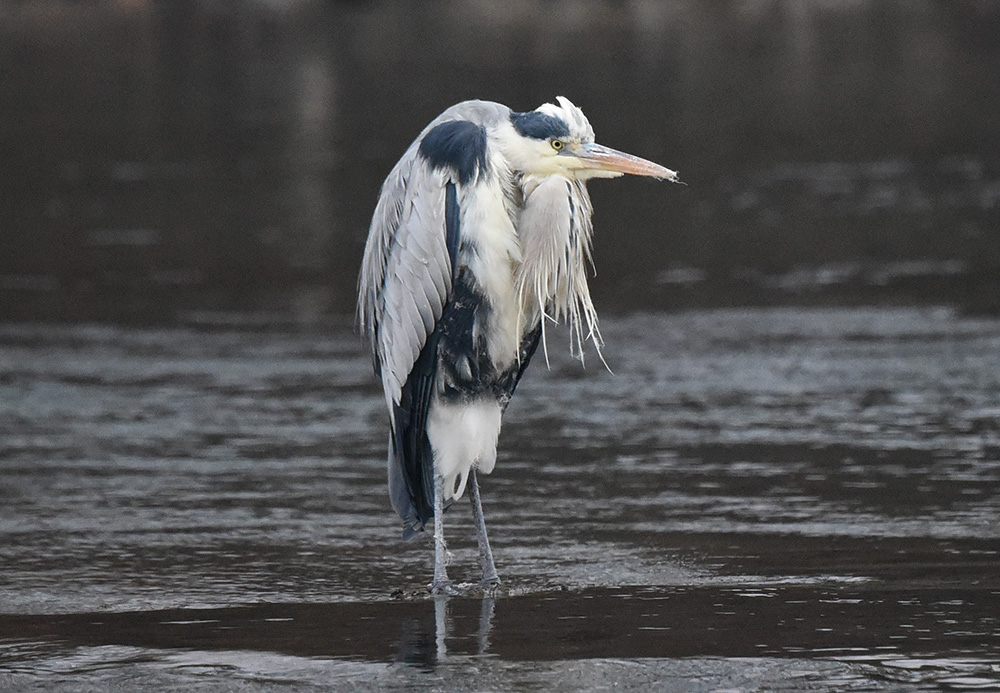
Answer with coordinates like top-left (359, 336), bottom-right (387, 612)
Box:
top-left (0, 0), bottom-right (1000, 323)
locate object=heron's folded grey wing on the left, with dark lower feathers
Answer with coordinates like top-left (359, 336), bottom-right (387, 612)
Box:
top-left (359, 145), bottom-right (454, 538)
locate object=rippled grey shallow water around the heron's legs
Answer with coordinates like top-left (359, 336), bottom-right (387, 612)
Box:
top-left (0, 308), bottom-right (1000, 691)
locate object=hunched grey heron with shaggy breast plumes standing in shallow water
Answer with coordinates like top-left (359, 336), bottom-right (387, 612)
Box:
top-left (359, 97), bottom-right (677, 593)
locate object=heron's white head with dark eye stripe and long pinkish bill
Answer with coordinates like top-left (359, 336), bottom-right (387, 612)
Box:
top-left (505, 96), bottom-right (677, 182)
